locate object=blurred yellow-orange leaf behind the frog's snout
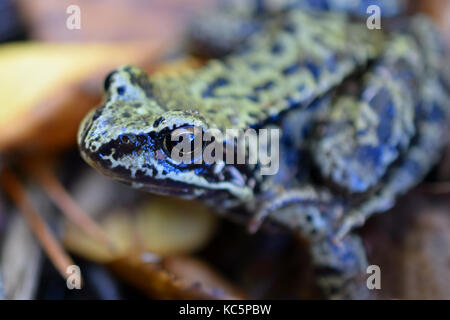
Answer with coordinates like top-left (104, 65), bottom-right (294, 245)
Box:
top-left (0, 43), bottom-right (163, 151)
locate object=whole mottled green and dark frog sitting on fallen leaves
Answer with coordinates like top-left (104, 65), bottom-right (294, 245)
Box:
top-left (78, 1), bottom-right (448, 298)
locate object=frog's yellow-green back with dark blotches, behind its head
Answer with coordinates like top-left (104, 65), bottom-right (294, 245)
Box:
top-left (151, 10), bottom-right (384, 129)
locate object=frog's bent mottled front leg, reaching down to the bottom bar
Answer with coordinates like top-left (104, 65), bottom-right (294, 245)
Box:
top-left (255, 187), bottom-right (369, 299)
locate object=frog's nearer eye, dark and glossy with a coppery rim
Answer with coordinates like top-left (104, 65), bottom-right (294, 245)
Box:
top-left (163, 126), bottom-right (202, 158)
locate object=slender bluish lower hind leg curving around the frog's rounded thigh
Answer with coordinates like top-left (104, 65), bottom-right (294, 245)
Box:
top-left (336, 76), bottom-right (449, 238)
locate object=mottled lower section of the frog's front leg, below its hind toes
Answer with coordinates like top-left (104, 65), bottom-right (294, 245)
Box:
top-left (311, 235), bottom-right (370, 299)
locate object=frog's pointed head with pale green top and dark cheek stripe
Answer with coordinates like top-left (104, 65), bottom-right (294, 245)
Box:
top-left (78, 66), bottom-right (252, 205)
